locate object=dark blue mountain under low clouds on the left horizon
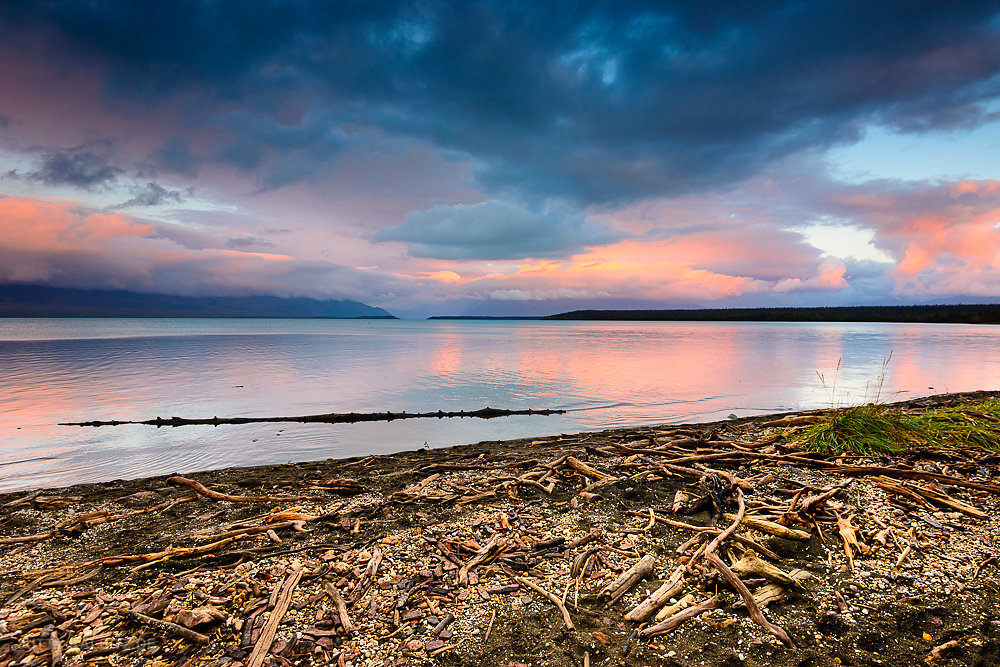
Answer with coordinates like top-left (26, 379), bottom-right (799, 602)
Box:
top-left (0, 285), bottom-right (395, 319)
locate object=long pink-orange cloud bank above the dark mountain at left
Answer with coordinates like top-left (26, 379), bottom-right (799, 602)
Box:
top-left (0, 197), bottom-right (412, 303)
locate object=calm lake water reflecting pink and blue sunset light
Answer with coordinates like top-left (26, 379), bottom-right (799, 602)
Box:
top-left (0, 319), bottom-right (1000, 490)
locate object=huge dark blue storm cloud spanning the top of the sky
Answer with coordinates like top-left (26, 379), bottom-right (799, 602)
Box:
top-left (0, 0), bottom-right (1000, 203)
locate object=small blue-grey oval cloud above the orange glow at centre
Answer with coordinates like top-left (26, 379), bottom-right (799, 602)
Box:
top-left (375, 200), bottom-right (624, 260)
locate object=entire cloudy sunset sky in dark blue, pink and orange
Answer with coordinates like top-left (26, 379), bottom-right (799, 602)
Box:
top-left (0, 0), bottom-right (1000, 317)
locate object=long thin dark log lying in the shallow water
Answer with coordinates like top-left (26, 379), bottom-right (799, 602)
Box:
top-left (59, 407), bottom-right (566, 426)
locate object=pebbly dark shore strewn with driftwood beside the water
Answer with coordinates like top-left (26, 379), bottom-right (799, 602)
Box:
top-left (0, 393), bottom-right (1000, 667)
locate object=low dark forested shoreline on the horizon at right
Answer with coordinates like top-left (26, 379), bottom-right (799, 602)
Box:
top-left (542, 304), bottom-right (1000, 324)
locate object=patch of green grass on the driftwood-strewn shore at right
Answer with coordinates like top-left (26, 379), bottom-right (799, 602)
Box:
top-left (799, 400), bottom-right (1000, 456)
